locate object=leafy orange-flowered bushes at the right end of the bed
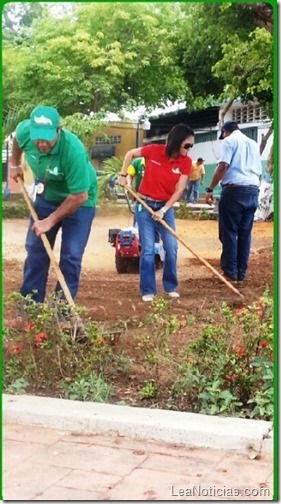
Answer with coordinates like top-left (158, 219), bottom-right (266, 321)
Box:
top-left (171, 293), bottom-right (273, 420)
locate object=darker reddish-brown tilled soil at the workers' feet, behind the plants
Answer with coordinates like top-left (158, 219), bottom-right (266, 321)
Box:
top-left (3, 249), bottom-right (273, 322)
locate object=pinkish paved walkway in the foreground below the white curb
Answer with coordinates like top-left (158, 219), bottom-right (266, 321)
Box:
top-left (3, 423), bottom-right (272, 501)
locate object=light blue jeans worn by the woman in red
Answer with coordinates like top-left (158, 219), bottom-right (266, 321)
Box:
top-left (135, 200), bottom-right (178, 296)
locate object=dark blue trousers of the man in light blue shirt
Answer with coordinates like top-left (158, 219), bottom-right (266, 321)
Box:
top-left (219, 186), bottom-right (259, 280)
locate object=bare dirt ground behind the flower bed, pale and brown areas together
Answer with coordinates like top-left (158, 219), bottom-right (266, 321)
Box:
top-left (2, 215), bottom-right (273, 322)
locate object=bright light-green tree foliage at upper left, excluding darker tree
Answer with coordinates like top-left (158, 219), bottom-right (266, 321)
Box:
top-left (3, 3), bottom-right (185, 116)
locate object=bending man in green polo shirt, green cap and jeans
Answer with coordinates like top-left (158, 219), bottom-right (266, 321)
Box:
top-left (10, 106), bottom-right (97, 302)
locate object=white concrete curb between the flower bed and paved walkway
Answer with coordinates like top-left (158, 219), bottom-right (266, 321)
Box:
top-left (3, 394), bottom-right (273, 455)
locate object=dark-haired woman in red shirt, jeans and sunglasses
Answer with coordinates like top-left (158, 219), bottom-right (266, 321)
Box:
top-left (117, 124), bottom-right (194, 302)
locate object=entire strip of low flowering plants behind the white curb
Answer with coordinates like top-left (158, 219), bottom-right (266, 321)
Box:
top-left (3, 292), bottom-right (273, 420)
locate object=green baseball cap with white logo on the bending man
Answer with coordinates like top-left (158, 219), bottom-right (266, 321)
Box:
top-left (30, 105), bottom-right (60, 142)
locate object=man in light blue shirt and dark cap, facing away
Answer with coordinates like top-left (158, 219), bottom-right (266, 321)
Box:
top-left (203, 121), bottom-right (262, 283)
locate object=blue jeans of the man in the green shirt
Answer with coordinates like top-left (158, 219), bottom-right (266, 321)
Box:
top-left (20, 197), bottom-right (95, 303)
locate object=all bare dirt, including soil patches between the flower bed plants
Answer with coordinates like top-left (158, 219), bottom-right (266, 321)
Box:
top-left (2, 215), bottom-right (273, 411)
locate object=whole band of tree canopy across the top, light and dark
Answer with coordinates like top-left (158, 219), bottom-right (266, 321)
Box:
top-left (2, 2), bottom-right (274, 122)
